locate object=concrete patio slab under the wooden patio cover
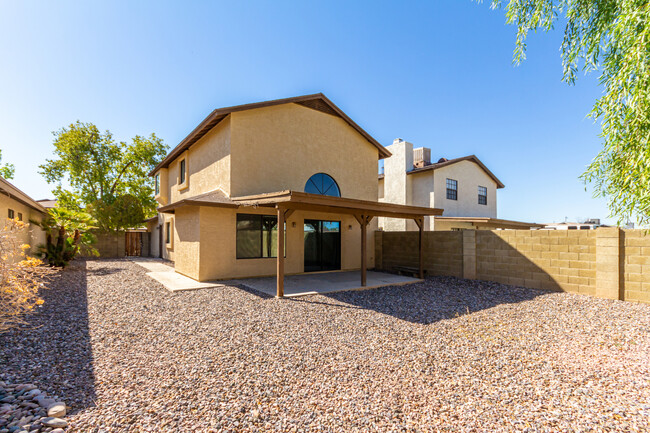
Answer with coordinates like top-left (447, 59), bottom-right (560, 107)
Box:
top-left (219, 271), bottom-right (422, 297)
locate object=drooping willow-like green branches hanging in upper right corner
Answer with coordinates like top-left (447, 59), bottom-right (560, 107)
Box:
top-left (492, 0), bottom-right (650, 224)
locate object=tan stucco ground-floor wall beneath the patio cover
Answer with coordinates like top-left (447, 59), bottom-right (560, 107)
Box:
top-left (172, 207), bottom-right (374, 281)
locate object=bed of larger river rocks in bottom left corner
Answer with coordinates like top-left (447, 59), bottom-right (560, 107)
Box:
top-left (0, 381), bottom-right (68, 433)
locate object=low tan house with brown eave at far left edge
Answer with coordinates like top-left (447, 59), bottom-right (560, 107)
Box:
top-left (0, 177), bottom-right (47, 252)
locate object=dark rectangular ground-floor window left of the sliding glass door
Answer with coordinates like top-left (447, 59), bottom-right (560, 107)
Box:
top-left (237, 214), bottom-right (287, 259)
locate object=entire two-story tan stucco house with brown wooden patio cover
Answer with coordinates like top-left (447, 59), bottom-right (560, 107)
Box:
top-left (148, 94), bottom-right (442, 295)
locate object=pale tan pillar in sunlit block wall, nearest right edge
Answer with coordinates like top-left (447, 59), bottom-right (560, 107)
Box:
top-left (596, 227), bottom-right (622, 299)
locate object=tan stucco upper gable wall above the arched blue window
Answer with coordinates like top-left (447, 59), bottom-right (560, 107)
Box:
top-left (230, 104), bottom-right (378, 200)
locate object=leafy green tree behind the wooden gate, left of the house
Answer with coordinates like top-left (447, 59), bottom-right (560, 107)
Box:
top-left (40, 121), bottom-right (168, 231)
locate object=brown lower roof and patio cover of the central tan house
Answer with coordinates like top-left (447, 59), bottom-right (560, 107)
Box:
top-left (158, 190), bottom-right (443, 218)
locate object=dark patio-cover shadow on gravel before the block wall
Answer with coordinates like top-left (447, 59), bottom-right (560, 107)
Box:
top-left (323, 277), bottom-right (551, 324)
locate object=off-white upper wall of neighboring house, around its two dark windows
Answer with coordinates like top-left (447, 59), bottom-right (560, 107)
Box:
top-left (434, 161), bottom-right (497, 218)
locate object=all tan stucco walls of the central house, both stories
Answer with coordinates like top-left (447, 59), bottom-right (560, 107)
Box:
top-left (152, 104), bottom-right (378, 281)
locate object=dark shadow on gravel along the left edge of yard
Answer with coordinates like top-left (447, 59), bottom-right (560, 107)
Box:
top-left (0, 260), bottom-right (96, 413)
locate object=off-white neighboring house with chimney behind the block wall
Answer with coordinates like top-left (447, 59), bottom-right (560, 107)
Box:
top-left (378, 138), bottom-right (543, 231)
